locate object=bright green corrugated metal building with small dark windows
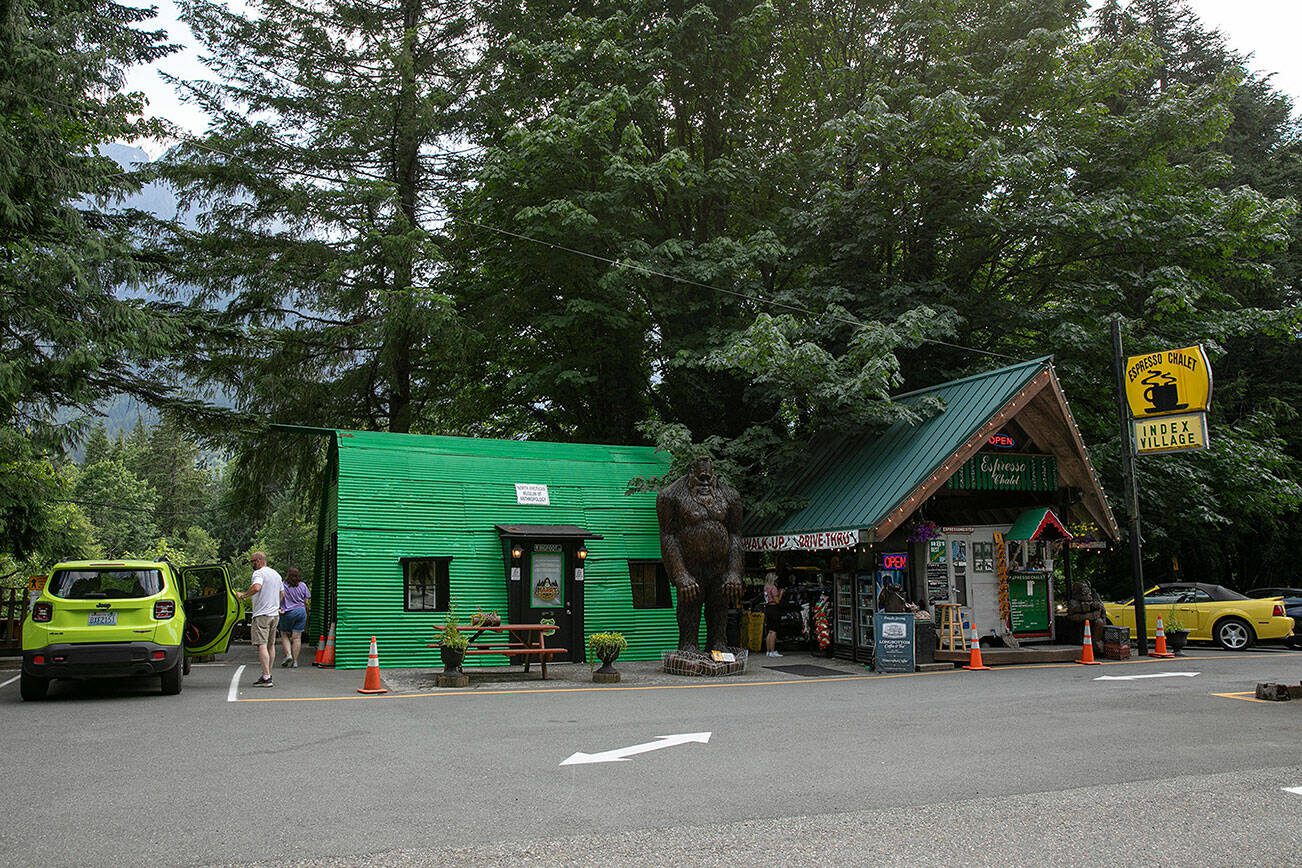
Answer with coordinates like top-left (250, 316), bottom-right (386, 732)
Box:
top-left (309, 431), bottom-right (677, 668)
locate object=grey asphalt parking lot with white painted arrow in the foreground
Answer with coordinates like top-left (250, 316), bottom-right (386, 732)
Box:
top-left (0, 647), bottom-right (1302, 865)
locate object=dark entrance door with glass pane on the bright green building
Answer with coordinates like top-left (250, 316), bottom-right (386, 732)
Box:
top-left (519, 541), bottom-right (583, 661)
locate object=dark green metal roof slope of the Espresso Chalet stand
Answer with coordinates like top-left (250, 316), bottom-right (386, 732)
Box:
top-left (745, 357), bottom-right (1049, 536)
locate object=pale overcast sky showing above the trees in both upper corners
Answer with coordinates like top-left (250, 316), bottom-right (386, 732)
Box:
top-left (128, 0), bottom-right (1302, 156)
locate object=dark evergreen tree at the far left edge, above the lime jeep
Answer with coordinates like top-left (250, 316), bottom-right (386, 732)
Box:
top-left (0, 0), bottom-right (181, 558)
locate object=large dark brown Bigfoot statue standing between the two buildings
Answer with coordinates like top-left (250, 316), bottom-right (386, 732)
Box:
top-left (655, 458), bottom-right (743, 651)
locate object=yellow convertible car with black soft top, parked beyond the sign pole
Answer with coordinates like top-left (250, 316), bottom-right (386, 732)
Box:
top-left (1103, 582), bottom-right (1293, 651)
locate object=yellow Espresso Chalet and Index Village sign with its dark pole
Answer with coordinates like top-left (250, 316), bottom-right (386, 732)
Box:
top-left (1112, 325), bottom-right (1212, 656)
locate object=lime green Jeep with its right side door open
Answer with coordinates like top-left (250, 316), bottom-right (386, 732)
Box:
top-left (20, 561), bottom-right (240, 701)
